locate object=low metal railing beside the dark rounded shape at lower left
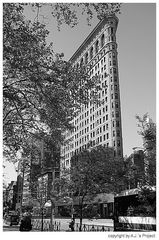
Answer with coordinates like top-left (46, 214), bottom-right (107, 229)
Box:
top-left (32, 219), bottom-right (61, 231)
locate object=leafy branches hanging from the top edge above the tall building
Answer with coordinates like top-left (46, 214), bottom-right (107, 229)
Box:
top-left (27, 2), bottom-right (121, 30)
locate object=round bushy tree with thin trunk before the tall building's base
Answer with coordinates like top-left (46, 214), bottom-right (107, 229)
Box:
top-left (56, 146), bottom-right (125, 230)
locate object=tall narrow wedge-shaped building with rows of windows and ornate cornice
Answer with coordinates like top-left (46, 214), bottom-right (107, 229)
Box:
top-left (61, 15), bottom-right (123, 168)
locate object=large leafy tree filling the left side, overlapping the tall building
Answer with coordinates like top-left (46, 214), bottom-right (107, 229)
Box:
top-left (3, 3), bottom-right (102, 159)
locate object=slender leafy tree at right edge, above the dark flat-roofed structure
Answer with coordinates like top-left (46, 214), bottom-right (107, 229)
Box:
top-left (136, 113), bottom-right (156, 186)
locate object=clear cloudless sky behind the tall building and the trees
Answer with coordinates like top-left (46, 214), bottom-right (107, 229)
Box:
top-left (2, 2), bottom-right (156, 185)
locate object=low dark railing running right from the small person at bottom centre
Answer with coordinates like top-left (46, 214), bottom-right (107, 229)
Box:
top-left (75, 223), bottom-right (114, 232)
